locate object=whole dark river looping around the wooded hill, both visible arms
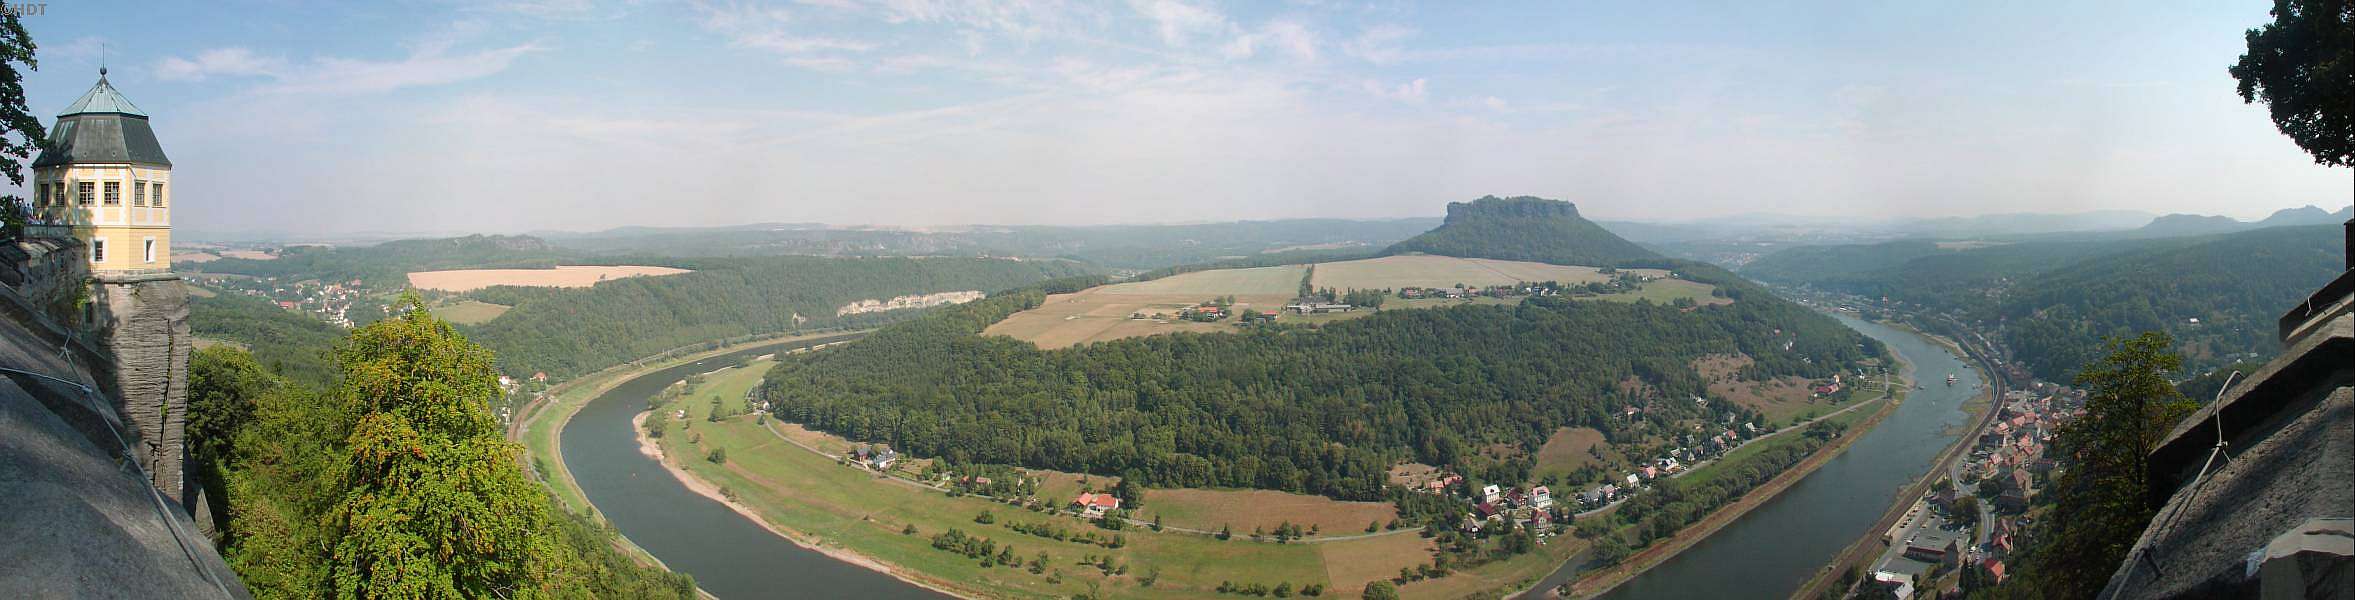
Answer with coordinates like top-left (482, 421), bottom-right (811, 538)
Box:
top-left (579, 315), bottom-right (1981, 600)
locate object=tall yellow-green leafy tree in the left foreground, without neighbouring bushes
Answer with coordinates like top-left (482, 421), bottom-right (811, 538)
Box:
top-left (323, 296), bottom-right (563, 598)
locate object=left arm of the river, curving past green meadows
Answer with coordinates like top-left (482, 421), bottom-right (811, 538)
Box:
top-left (563, 336), bottom-right (942, 600)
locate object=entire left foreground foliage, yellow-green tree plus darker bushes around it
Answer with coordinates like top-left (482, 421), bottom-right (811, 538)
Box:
top-left (191, 299), bottom-right (695, 598)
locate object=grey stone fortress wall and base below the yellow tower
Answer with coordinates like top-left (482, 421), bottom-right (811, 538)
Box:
top-left (0, 240), bottom-right (250, 598)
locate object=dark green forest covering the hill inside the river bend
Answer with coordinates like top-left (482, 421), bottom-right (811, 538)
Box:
top-left (761, 200), bottom-right (1882, 499)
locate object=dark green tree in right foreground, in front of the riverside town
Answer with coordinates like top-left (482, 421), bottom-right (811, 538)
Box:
top-left (2030, 332), bottom-right (2193, 598)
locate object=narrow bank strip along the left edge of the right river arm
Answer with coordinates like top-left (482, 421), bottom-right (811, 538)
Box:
top-left (1550, 391), bottom-right (1905, 598)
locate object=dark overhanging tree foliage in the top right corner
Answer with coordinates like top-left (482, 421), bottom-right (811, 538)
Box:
top-left (2230, 0), bottom-right (2355, 167)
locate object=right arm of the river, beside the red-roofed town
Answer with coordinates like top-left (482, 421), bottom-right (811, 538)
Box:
top-left (1533, 315), bottom-right (1983, 600)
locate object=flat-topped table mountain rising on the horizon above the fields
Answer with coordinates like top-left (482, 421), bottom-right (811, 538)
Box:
top-left (1382, 195), bottom-right (1663, 266)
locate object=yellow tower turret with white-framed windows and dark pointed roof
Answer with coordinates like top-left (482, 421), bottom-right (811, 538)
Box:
top-left (33, 68), bottom-right (172, 275)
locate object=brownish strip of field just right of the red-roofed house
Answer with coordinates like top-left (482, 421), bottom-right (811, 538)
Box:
top-left (1135, 487), bottom-right (1399, 534)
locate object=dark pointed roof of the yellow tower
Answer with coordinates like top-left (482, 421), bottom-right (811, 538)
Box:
top-left (33, 68), bottom-right (172, 167)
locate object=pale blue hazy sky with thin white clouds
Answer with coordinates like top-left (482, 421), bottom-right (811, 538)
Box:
top-left (9, 0), bottom-right (2350, 233)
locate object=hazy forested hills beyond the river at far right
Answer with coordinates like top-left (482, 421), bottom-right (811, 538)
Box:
top-left (1743, 226), bottom-right (2343, 381)
